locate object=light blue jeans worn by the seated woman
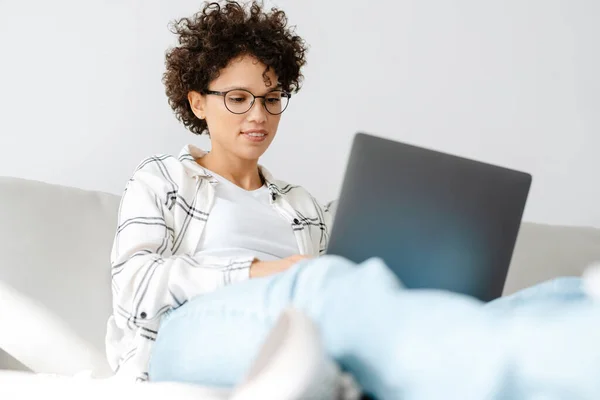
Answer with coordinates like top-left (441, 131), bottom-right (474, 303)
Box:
top-left (149, 256), bottom-right (600, 399)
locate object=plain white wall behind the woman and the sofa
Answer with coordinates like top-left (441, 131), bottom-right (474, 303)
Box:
top-left (0, 0), bottom-right (600, 227)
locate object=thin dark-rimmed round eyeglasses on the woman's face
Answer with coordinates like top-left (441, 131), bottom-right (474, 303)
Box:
top-left (204, 89), bottom-right (292, 115)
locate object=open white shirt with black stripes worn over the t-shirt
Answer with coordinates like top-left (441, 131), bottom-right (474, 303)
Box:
top-left (106, 145), bottom-right (332, 381)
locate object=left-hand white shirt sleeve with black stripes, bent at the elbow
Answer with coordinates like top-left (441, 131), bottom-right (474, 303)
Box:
top-left (111, 170), bottom-right (254, 329)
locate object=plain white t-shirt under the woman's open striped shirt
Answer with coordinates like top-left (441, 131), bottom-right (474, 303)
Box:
top-left (198, 173), bottom-right (299, 261)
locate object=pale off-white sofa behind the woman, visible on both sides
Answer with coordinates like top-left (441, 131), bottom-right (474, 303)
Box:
top-left (0, 177), bottom-right (600, 384)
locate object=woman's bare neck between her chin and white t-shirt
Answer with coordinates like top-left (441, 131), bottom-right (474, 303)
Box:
top-left (196, 148), bottom-right (264, 190)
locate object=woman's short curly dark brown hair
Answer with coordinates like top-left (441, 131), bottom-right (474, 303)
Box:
top-left (163, 1), bottom-right (307, 135)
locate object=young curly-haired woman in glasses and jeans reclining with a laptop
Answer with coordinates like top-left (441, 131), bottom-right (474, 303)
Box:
top-left (107, 2), bottom-right (600, 399)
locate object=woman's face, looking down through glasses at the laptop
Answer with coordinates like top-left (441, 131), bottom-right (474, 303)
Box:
top-left (188, 55), bottom-right (281, 160)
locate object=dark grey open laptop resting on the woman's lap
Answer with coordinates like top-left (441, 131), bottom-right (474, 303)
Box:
top-left (327, 133), bottom-right (532, 302)
